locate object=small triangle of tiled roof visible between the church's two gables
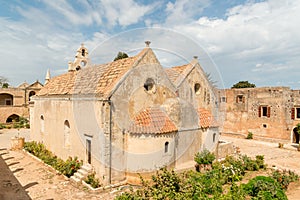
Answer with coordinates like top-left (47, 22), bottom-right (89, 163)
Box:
top-left (165, 64), bottom-right (192, 86)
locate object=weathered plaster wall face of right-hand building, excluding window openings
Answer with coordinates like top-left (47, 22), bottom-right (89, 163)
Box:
top-left (223, 87), bottom-right (293, 140)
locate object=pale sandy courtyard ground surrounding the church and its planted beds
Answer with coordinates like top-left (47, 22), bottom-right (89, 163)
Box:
top-left (0, 129), bottom-right (300, 199)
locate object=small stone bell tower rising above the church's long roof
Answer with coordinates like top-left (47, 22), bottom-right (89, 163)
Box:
top-left (68, 44), bottom-right (90, 71)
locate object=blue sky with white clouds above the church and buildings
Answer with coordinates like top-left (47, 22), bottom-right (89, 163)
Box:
top-left (0, 0), bottom-right (300, 89)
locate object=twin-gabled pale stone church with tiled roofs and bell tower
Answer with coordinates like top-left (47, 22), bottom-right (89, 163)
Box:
top-left (30, 42), bottom-right (219, 185)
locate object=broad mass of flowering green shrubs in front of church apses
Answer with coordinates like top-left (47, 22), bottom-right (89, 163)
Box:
top-left (116, 155), bottom-right (298, 200)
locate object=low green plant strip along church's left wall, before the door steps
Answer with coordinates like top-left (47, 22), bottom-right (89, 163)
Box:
top-left (24, 141), bottom-right (83, 177)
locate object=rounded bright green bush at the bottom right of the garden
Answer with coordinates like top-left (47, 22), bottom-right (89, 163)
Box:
top-left (243, 176), bottom-right (287, 200)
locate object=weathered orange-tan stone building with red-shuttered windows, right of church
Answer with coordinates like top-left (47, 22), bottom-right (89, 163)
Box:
top-left (219, 87), bottom-right (300, 143)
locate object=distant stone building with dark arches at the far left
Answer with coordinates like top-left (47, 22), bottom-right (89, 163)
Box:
top-left (0, 81), bottom-right (43, 123)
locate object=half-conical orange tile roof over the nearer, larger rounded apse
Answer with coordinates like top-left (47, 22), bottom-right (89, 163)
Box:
top-left (128, 107), bottom-right (178, 134)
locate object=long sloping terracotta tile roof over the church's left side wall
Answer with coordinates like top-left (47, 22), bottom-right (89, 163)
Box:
top-left (38, 48), bottom-right (149, 97)
